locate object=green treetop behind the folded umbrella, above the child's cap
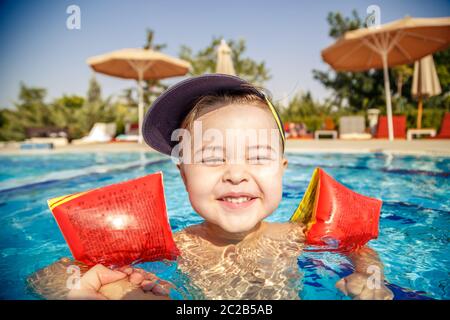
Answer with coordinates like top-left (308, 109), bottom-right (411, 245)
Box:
top-left (179, 37), bottom-right (271, 86)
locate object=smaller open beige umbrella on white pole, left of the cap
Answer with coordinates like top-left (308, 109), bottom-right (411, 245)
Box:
top-left (87, 48), bottom-right (190, 143)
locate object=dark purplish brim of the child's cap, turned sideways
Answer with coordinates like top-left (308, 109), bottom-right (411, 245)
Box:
top-left (142, 74), bottom-right (248, 155)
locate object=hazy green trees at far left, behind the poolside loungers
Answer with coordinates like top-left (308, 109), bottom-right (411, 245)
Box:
top-left (0, 77), bottom-right (135, 141)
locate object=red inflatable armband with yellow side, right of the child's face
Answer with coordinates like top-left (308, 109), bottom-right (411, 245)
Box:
top-left (291, 168), bottom-right (382, 250)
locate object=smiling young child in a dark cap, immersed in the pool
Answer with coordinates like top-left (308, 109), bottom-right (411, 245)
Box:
top-left (31, 74), bottom-right (393, 299)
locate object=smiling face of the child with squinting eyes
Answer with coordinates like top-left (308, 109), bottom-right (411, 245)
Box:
top-left (179, 105), bottom-right (287, 233)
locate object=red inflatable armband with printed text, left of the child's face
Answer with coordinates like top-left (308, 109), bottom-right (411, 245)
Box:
top-left (48, 172), bottom-right (179, 266)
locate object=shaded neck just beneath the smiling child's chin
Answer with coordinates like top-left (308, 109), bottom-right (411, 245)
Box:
top-left (203, 221), bottom-right (265, 245)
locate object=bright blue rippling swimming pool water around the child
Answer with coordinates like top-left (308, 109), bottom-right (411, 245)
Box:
top-left (0, 152), bottom-right (450, 299)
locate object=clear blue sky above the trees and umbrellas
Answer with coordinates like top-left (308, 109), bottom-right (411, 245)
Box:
top-left (0, 0), bottom-right (450, 108)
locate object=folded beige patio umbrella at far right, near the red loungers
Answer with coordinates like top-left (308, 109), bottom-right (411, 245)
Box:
top-left (411, 54), bottom-right (442, 129)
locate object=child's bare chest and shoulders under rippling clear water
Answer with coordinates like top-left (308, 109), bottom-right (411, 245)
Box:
top-left (176, 224), bottom-right (303, 299)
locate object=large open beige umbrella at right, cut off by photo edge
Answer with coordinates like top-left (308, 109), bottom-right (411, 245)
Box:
top-left (322, 17), bottom-right (450, 140)
